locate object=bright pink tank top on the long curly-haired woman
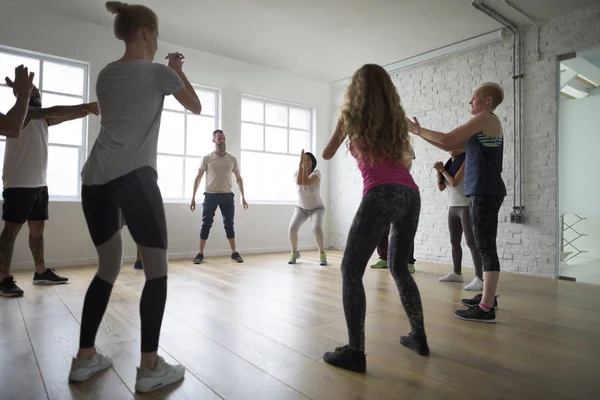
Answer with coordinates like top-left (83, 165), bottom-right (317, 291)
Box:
top-left (350, 144), bottom-right (419, 196)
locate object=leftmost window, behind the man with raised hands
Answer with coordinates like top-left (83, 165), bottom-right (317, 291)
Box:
top-left (0, 46), bottom-right (88, 199)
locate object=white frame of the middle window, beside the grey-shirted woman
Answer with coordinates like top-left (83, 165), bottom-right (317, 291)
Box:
top-left (156, 83), bottom-right (222, 204)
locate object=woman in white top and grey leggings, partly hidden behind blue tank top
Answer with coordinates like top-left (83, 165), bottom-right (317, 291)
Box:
top-left (433, 150), bottom-right (483, 290)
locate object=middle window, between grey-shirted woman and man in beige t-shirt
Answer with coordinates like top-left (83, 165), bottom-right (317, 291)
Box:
top-left (157, 86), bottom-right (219, 202)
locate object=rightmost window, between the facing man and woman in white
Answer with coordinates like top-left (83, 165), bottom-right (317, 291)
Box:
top-left (240, 96), bottom-right (313, 203)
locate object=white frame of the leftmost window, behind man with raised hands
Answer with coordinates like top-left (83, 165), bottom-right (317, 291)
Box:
top-left (0, 44), bottom-right (90, 202)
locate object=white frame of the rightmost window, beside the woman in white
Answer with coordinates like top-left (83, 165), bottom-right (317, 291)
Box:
top-left (239, 93), bottom-right (316, 205)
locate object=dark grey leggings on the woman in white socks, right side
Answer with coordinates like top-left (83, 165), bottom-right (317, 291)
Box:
top-left (448, 206), bottom-right (483, 279)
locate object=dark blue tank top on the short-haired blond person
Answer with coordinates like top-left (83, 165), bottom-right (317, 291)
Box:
top-left (465, 133), bottom-right (506, 197)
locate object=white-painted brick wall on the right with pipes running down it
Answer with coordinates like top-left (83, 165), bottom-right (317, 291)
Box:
top-left (329, 6), bottom-right (600, 276)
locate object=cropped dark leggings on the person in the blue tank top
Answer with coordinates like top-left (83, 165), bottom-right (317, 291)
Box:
top-left (469, 195), bottom-right (504, 272)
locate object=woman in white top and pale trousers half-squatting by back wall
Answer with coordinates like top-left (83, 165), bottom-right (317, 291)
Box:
top-left (288, 150), bottom-right (327, 265)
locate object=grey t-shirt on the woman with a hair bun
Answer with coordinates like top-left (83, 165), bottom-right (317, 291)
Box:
top-left (81, 60), bottom-right (184, 185)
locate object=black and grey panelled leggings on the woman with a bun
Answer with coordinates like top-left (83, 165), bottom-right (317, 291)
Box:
top-left (79, 167), bottom-right (168, 353)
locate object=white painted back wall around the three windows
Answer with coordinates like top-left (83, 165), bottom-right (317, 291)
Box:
top-left (0, 3), bottom-right (330, 268)
